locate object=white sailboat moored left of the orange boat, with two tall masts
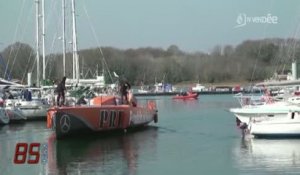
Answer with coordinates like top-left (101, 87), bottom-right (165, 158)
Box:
top-left (4, 0), bottom-right (50, 120)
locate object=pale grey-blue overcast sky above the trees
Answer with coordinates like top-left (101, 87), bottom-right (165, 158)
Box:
top-left (0, 0), bottom-right (300, 54)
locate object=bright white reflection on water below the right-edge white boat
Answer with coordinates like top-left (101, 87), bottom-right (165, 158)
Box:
top-left (233, 138), bottom-right (300, 174)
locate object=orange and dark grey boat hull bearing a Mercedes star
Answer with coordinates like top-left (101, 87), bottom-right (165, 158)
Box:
top-left (47, 105), bottom-right (157, 139)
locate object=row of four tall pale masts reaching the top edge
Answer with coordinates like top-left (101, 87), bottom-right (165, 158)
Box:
top-left (35, 0), bottom-right (79, 87)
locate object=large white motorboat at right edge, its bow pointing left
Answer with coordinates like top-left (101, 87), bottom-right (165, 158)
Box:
top-left (230, 92), bottom-right (300, 137)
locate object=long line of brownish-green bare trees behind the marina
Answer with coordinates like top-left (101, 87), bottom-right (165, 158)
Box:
top-left (0, 38), bottom-right (300, 85)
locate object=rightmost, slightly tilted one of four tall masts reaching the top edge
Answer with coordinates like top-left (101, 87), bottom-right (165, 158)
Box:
top-left (72, 0), bottom-right (79, 83)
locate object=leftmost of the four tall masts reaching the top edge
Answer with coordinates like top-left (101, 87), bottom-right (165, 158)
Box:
top-left (35, 0), bottom-right (40, 86)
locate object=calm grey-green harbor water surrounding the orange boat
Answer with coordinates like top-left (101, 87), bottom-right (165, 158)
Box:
top-left (0, 95), bottom-right (300, 175)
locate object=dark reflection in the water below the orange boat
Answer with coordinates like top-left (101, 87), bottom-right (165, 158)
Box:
top-left (48, 126), bottom-right (157, 174)
